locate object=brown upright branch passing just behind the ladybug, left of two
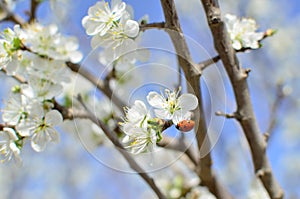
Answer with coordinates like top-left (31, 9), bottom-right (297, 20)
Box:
top-left (161, 0), bottom-right (232, 199)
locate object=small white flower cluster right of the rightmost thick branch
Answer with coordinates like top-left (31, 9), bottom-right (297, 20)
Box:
top-left (225, 14), bottom-right (264, 50)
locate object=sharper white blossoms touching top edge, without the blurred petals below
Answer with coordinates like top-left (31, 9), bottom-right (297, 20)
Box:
top-left (82, 0), bottom-right (139, 53)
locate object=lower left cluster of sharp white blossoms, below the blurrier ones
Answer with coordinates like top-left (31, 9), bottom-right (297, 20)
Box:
top-left (0, 91), bottom-right (63, 163)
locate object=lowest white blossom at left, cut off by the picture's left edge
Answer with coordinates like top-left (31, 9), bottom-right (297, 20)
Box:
top-left (0, 127), bottom-right (22, 165)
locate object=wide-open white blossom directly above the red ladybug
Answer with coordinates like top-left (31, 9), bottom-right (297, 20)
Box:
top-left (147, 89), bottom-right (198, 124)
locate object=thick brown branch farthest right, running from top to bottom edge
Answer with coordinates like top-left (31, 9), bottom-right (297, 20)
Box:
top-left (202, 0), bottom-right (283, 199)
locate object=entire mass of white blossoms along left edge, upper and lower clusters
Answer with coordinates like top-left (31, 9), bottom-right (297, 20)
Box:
top-left (0, 23), bottom-right (82, 162)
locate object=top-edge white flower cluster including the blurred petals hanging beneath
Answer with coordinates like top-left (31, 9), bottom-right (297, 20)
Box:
top-left (82, 0), bottom-right (147, 74)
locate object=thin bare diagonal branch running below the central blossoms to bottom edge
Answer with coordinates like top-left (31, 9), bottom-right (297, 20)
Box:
top-left (73, 96), bottom-right (166, 199)
